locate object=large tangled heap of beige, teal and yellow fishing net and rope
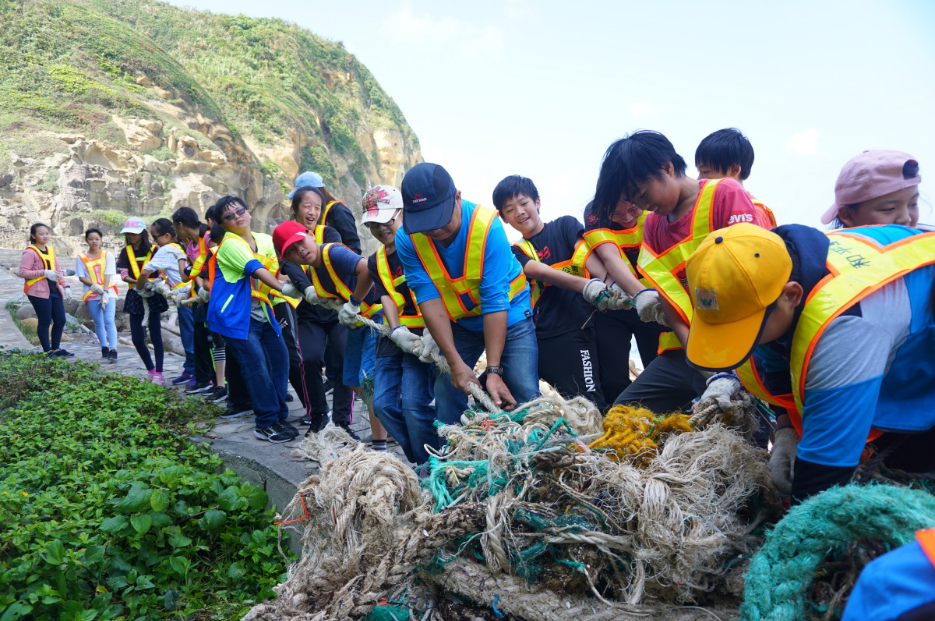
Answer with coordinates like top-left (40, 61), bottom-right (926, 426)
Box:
top-left (245, 391), bottom-right (778, 621)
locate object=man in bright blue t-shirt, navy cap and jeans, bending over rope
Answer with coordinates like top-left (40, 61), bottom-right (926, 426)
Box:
top-left (396, 163), bottom-right (539, 424)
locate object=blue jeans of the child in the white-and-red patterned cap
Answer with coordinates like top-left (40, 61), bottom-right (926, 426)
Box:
top-left (373, 343), bottom-right (441, 464)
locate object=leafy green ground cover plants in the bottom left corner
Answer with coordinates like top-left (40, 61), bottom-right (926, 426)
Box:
top-left (0, 353), bottom-right (286, 621)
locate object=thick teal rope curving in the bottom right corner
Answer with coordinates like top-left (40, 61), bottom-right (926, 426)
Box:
top-left (740, 484), bottom-right (935, 621)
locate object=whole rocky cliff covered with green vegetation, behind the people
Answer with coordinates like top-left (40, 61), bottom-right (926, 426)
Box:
top-left (0, 0), bottom-right (421, 250)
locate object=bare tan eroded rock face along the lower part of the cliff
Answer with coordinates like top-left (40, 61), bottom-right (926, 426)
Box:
top-left (0, 109), bottom-right (421, 254)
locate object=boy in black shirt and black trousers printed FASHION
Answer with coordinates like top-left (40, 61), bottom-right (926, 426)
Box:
top-left (493, 175), bottom-right (616, 409)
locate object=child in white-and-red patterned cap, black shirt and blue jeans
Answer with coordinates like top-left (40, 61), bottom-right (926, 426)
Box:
top-left (362, 185), bottom-right (440, 464)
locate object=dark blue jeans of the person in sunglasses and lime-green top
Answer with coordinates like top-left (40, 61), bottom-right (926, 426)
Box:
top-left (224, 319), bottom-right (289, 429)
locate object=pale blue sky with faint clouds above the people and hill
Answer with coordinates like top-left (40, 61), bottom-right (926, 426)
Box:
top-left (165, 0), bottom-right (935, 232)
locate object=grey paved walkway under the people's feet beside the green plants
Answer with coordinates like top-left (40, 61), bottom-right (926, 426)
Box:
top-left (0, 253), bottom-right (408, 552)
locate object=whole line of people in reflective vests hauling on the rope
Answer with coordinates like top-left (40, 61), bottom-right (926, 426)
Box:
top-left (20, 129), bottom-right (935, 616)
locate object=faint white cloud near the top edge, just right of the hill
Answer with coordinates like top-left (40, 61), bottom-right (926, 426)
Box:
top-left (387, 2), bottom-right (505, 61)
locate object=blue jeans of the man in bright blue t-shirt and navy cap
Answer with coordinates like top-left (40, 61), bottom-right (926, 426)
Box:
top-left (435, 317), bottom-right (539, 425)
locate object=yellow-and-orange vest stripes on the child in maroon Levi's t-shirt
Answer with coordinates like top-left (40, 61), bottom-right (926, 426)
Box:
top-left (637, 179), bottom-right (721, 324)
